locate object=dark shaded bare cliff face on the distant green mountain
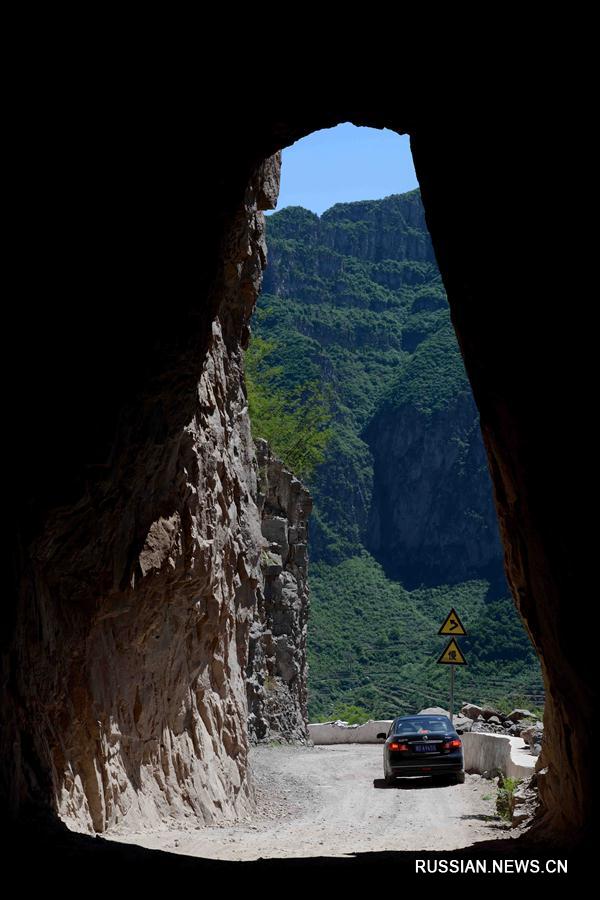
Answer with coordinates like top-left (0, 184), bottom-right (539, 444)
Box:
top-left (366, 391), bottom-right (502, 586)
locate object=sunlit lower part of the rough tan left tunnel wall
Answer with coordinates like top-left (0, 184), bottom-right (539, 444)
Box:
top-left (55, 321), bottom-right (259, 832)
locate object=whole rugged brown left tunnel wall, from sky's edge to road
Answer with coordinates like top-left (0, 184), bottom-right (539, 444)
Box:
top-left (3, 158), bottom-right (278, 832)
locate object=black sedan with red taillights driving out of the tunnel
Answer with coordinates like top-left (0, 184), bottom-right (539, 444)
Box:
top-left (377, 715), bottom-right (465, 784)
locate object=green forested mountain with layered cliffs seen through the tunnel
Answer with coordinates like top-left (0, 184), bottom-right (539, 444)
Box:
top-left (249, 191), bottom-right (541, 718)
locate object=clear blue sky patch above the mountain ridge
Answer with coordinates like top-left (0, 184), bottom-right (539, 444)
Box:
top-left (270, 123), bottom-right (419, 214)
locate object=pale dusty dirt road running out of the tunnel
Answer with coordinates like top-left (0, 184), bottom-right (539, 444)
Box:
top-left (106, 744), bottom-right (514, 860)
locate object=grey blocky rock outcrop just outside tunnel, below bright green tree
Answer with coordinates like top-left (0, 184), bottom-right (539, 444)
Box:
top-left (247, 440), bottom-right (312, 741)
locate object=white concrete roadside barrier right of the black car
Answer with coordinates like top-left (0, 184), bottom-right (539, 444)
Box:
top-left (461, 731), bottom-right (537, 779)
